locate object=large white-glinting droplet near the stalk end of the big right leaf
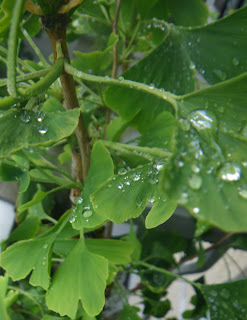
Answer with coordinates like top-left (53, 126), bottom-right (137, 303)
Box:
top-left (190, 110), bottom-right (217, 141)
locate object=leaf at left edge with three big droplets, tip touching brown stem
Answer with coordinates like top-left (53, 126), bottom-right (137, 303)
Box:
top-left (0, 109), bottom-right (79, 157)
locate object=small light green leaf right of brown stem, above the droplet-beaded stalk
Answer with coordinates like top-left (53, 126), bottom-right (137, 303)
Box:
top-left (72, 33), bottom-right (118, 74)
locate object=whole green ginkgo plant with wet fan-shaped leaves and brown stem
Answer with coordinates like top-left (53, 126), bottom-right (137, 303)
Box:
top-left (0, 0), bottom-right (247, 320)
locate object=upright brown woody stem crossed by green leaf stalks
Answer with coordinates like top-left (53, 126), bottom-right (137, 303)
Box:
top-left (41, 14), bottom-right (91, 183)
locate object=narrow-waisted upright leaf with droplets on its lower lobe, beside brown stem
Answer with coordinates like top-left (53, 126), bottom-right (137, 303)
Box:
top-left (71, 141), bottom-right (114, 230)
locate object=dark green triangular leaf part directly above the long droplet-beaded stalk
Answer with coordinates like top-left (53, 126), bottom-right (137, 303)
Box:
top-left (120, 27), bottom-right (194, 95)
